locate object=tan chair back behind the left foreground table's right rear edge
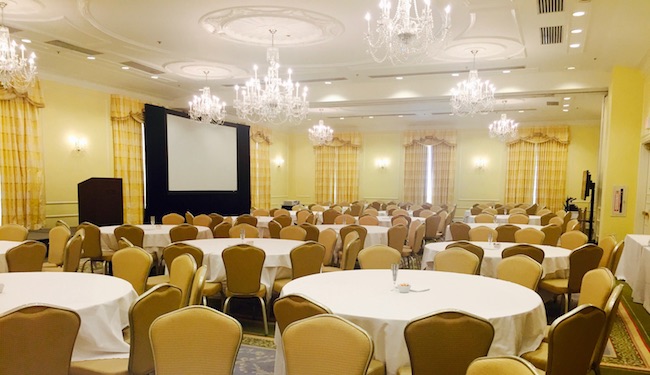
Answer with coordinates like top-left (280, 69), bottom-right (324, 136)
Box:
top-left (113, 247), bottom-right (153, 294)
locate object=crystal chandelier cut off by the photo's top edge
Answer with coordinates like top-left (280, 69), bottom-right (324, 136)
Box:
top-left (365, 0), bottom-right (451, 64)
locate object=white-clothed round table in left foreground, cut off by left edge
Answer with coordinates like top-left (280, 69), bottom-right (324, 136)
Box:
top-left (0, 272), bottom-right (138, 361)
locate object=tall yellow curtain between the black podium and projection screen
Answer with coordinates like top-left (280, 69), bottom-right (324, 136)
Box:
top-left (111, 95), bottom-right (144, 224)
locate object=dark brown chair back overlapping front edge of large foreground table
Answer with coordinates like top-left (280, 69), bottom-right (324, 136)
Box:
top-left (397, 310), bottom-right (494, 375)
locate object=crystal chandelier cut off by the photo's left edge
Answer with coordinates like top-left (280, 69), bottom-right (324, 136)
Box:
top-left (0, 2), bottom-right (36, 92)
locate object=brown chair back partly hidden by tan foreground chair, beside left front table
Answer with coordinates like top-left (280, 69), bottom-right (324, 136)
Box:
top-left (127, 284), bottom-right (182, 375)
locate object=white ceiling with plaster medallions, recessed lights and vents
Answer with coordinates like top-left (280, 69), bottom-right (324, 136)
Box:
top-left (5, 0), bottom-right (650, 131)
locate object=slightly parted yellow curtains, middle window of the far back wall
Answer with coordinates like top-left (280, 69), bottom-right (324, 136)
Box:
top-left (404, 130), bottom-right (456, 204)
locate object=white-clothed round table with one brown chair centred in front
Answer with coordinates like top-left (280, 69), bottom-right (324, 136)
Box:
top-left (183, 238), bottom-right (305, 300)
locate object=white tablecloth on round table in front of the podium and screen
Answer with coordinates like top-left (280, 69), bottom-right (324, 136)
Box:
top-left (100, 224), bottom-right (212, 259)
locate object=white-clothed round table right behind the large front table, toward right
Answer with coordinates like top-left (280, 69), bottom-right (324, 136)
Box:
top-left (422, 241), bottom-right (571, 279)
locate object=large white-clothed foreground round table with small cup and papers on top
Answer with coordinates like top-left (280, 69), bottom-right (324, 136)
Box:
top-left (275, 270), bottom-right (546, 375)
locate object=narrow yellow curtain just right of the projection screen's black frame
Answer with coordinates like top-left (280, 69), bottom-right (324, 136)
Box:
top-left (250, 126), bottom-right (271, 209)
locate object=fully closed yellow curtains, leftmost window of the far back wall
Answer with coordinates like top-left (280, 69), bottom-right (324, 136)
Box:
top-left (314, 133), bottom-right (361, 202)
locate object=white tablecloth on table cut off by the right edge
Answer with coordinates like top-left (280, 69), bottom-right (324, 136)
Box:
top-left (616, 234), bottom-right (650, 312)
